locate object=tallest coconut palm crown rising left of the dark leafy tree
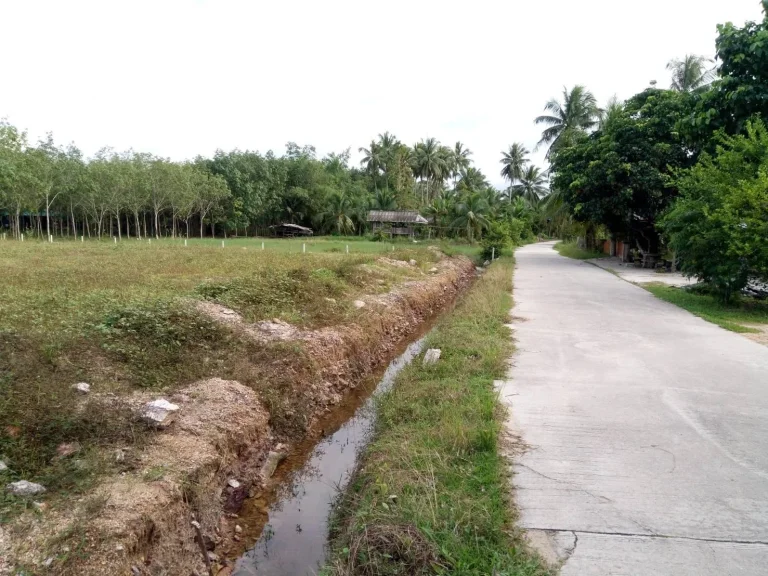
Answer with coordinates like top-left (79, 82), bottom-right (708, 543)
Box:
top-left (534, 84), bottom-right (600, 159)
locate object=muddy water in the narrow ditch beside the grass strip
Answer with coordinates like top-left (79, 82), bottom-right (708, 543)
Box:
top-left (232, 336), bottom-right (424, 576)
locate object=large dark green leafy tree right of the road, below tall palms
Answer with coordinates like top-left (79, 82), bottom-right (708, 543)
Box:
top-left (552, 89), bottom-right (695, 251)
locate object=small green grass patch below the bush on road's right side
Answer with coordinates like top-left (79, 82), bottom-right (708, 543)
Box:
top-left (642, 283), bottom-right (768, 333)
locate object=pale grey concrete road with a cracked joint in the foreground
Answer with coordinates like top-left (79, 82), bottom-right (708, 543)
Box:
top-left (500, 243), bottom-right (768, 576)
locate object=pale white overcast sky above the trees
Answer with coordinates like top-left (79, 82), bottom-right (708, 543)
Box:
top-left (0, 0), bottom-right (762, 186)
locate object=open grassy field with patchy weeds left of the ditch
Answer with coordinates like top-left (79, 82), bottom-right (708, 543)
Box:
top-left (0, 239), bottom-right (474, 522)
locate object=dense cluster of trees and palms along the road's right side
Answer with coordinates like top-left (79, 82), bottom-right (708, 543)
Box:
top-left (535, 1), bottom-right (768, 300)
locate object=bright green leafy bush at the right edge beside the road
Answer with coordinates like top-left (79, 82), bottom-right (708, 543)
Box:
top-left (661, 120), bottom-right (768, 302)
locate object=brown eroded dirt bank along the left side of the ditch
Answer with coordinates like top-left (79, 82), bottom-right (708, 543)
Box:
top-left (0, 257), bottom-right (474, 576)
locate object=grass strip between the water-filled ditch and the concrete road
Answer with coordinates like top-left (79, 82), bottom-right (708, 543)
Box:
top-left (325, 258), bottom-right (546, 576)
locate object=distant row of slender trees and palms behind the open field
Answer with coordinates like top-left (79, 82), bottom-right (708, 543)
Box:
top-left (0, 121), bottom-right (548, 240)
